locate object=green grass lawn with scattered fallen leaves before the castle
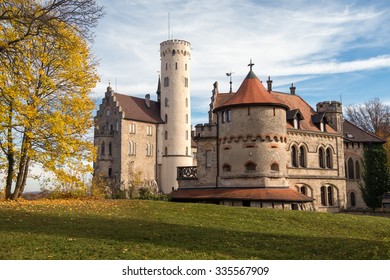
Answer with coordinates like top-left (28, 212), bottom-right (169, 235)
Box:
top-left (0, 200), bottom-right (390, 260)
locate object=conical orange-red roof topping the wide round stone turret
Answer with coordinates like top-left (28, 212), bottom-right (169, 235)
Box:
top-left (216, 64), bottom-right (288, 110)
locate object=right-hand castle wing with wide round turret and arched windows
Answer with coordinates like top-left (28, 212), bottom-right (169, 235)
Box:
top-left (176, 64), bottom-right (381, 212)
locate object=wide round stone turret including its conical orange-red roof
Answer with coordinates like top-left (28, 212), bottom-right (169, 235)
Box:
top-left (215, 67), bottom-right (288, 187)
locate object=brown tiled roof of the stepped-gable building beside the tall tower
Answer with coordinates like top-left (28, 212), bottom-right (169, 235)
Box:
top-left (114, 93), bottom-right (163, 123)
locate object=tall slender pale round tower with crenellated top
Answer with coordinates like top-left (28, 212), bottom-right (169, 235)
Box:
top-left (159, 40), bottom-right (192, 193)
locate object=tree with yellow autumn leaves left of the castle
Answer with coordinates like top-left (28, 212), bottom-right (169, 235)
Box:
top-left (0, 0), bottom-right (102, 199)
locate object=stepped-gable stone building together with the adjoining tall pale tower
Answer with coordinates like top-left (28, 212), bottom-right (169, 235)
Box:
top-left (94, 40), bottom-right (196, 193)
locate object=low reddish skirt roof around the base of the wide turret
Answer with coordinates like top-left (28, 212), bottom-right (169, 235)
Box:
top-left (171, 188), bottom-right (314, 202)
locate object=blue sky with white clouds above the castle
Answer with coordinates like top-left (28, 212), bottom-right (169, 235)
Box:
top-left (93, 0), bottom-right (390, 125)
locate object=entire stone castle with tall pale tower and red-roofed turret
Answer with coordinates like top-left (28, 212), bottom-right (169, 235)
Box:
top-left (94, 40), bottom-right (383, 212)
